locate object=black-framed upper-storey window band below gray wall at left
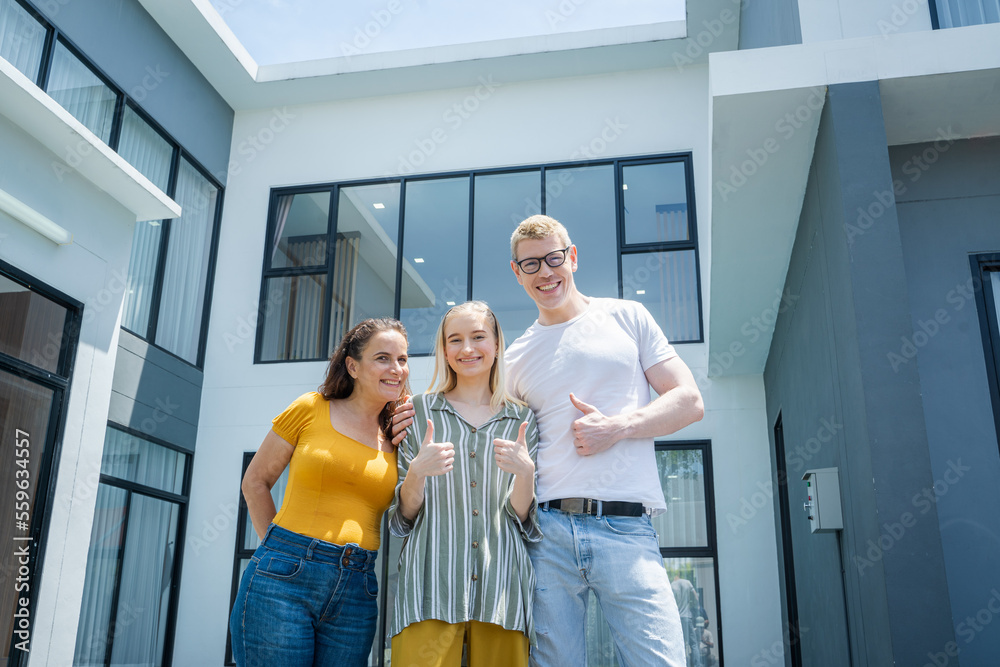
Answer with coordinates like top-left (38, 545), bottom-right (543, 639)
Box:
top-left (0, 0), bottom-right (223, 368)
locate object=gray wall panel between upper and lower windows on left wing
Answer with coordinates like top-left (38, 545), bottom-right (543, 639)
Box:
top-left (108, 329), bottom-right (202, 452)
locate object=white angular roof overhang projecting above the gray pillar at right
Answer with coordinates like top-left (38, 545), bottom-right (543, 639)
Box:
top-left (708, 24), bottom-right (1000, 376)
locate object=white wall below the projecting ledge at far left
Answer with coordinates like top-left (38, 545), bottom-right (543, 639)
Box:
top-left (0, 116), bottom-right (135, 667)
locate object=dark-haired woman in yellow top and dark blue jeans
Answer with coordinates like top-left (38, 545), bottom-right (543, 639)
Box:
top-left (229, 319), bottom-right (409, 667)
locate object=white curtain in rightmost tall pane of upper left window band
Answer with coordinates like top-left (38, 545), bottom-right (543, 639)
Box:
top-left (156, 160), bottom-right (219, 364)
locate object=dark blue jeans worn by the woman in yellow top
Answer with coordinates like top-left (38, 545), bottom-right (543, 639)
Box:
top-left (229, 524), bottom-right (378, 667)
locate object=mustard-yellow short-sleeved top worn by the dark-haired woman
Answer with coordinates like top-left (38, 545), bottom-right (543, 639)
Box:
top-left (272, 392), bottom-right (397, 550)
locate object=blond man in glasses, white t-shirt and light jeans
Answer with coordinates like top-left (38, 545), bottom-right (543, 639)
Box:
top-left (506, 215), bottom-right (704, 667)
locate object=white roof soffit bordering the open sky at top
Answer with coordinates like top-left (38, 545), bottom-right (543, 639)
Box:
top-left (140, 0), bottom-right (739, 111)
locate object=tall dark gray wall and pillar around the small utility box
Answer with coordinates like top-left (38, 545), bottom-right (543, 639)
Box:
top-left (764, 82), bottom-right (954, 666)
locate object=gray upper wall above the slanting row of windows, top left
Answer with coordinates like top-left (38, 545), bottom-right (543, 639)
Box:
top-left (34, 0), bottom-right (233, 185)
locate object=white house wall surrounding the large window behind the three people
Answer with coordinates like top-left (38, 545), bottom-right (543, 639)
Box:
top-left (174, 63), bottom-right (781, 665)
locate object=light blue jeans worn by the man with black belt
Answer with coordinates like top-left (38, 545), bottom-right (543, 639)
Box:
top-left (528, 509), bottom-right (686, 667)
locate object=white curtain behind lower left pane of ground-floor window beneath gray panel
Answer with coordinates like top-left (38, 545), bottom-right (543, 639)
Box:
top-left (73, 484), bottom-right (128, 667)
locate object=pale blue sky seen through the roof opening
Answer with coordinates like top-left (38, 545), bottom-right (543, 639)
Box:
top-left (211, 0), bottom-right (685, 65)
